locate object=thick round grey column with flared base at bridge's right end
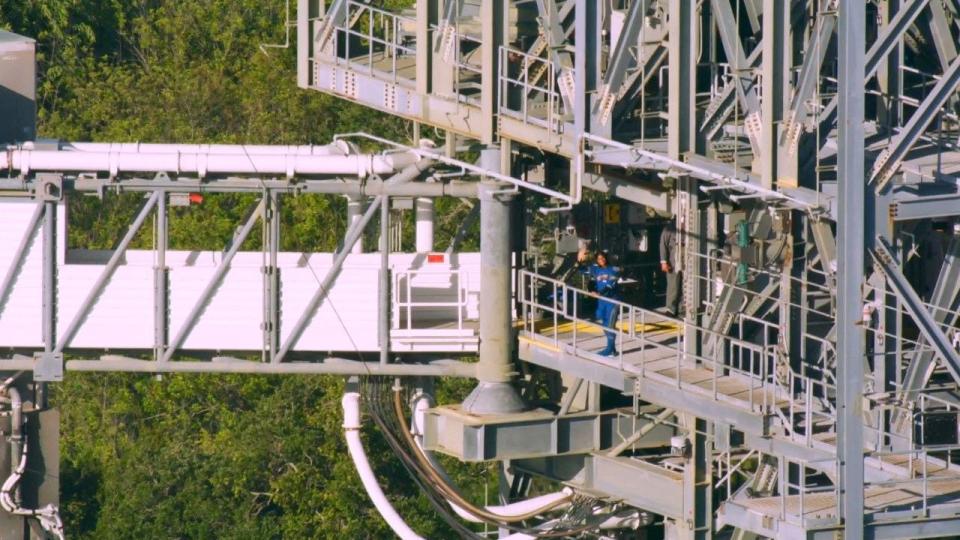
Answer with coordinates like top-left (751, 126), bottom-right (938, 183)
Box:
top-left (463, 147), bottom-right (525, 414)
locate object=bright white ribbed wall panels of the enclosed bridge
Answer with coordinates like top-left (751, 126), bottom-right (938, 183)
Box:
top-left (0, 196), bottom-right (480, 353)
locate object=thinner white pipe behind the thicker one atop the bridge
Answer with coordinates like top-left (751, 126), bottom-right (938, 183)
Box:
top-left (46, 141), bottom-right (353, 156)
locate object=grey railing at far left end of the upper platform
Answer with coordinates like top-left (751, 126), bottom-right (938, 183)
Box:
top-left (326, 0), bottom-right (417, 86)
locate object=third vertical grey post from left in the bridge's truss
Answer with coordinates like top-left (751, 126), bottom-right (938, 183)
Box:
top-left (262, 190), bottom-right (280, 362)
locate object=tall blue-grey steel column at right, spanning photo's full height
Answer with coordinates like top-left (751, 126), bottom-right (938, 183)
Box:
top-left (837, 0), bottom-right (872, 540)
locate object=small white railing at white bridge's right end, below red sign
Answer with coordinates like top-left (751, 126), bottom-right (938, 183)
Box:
top-left (391, 270), bottom-right (469, 330)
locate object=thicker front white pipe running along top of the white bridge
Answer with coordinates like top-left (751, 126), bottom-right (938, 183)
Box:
top-left (0, 144), bottom-right (420, 178)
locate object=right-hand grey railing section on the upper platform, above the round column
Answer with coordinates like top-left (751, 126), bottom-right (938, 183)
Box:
top-left (498, 47), bottom-right (564, 133)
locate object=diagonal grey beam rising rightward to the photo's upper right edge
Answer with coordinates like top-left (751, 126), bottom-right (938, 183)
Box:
top-left (870, 50), bottom-right (960, 192)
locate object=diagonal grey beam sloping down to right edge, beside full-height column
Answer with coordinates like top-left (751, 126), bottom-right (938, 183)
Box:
top-left (872, 238), bottom-right (960, 383)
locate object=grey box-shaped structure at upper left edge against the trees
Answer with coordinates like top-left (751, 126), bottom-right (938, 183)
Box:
top-left (0, 30), bottom-right (37, 144)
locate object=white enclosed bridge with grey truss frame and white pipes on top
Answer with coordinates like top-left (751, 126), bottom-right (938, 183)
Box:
top-left (0, 142), bottom-right (520, 380)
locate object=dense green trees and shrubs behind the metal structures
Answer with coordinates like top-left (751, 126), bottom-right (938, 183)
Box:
top-left (0, 0), bottom-right (491, 539)
